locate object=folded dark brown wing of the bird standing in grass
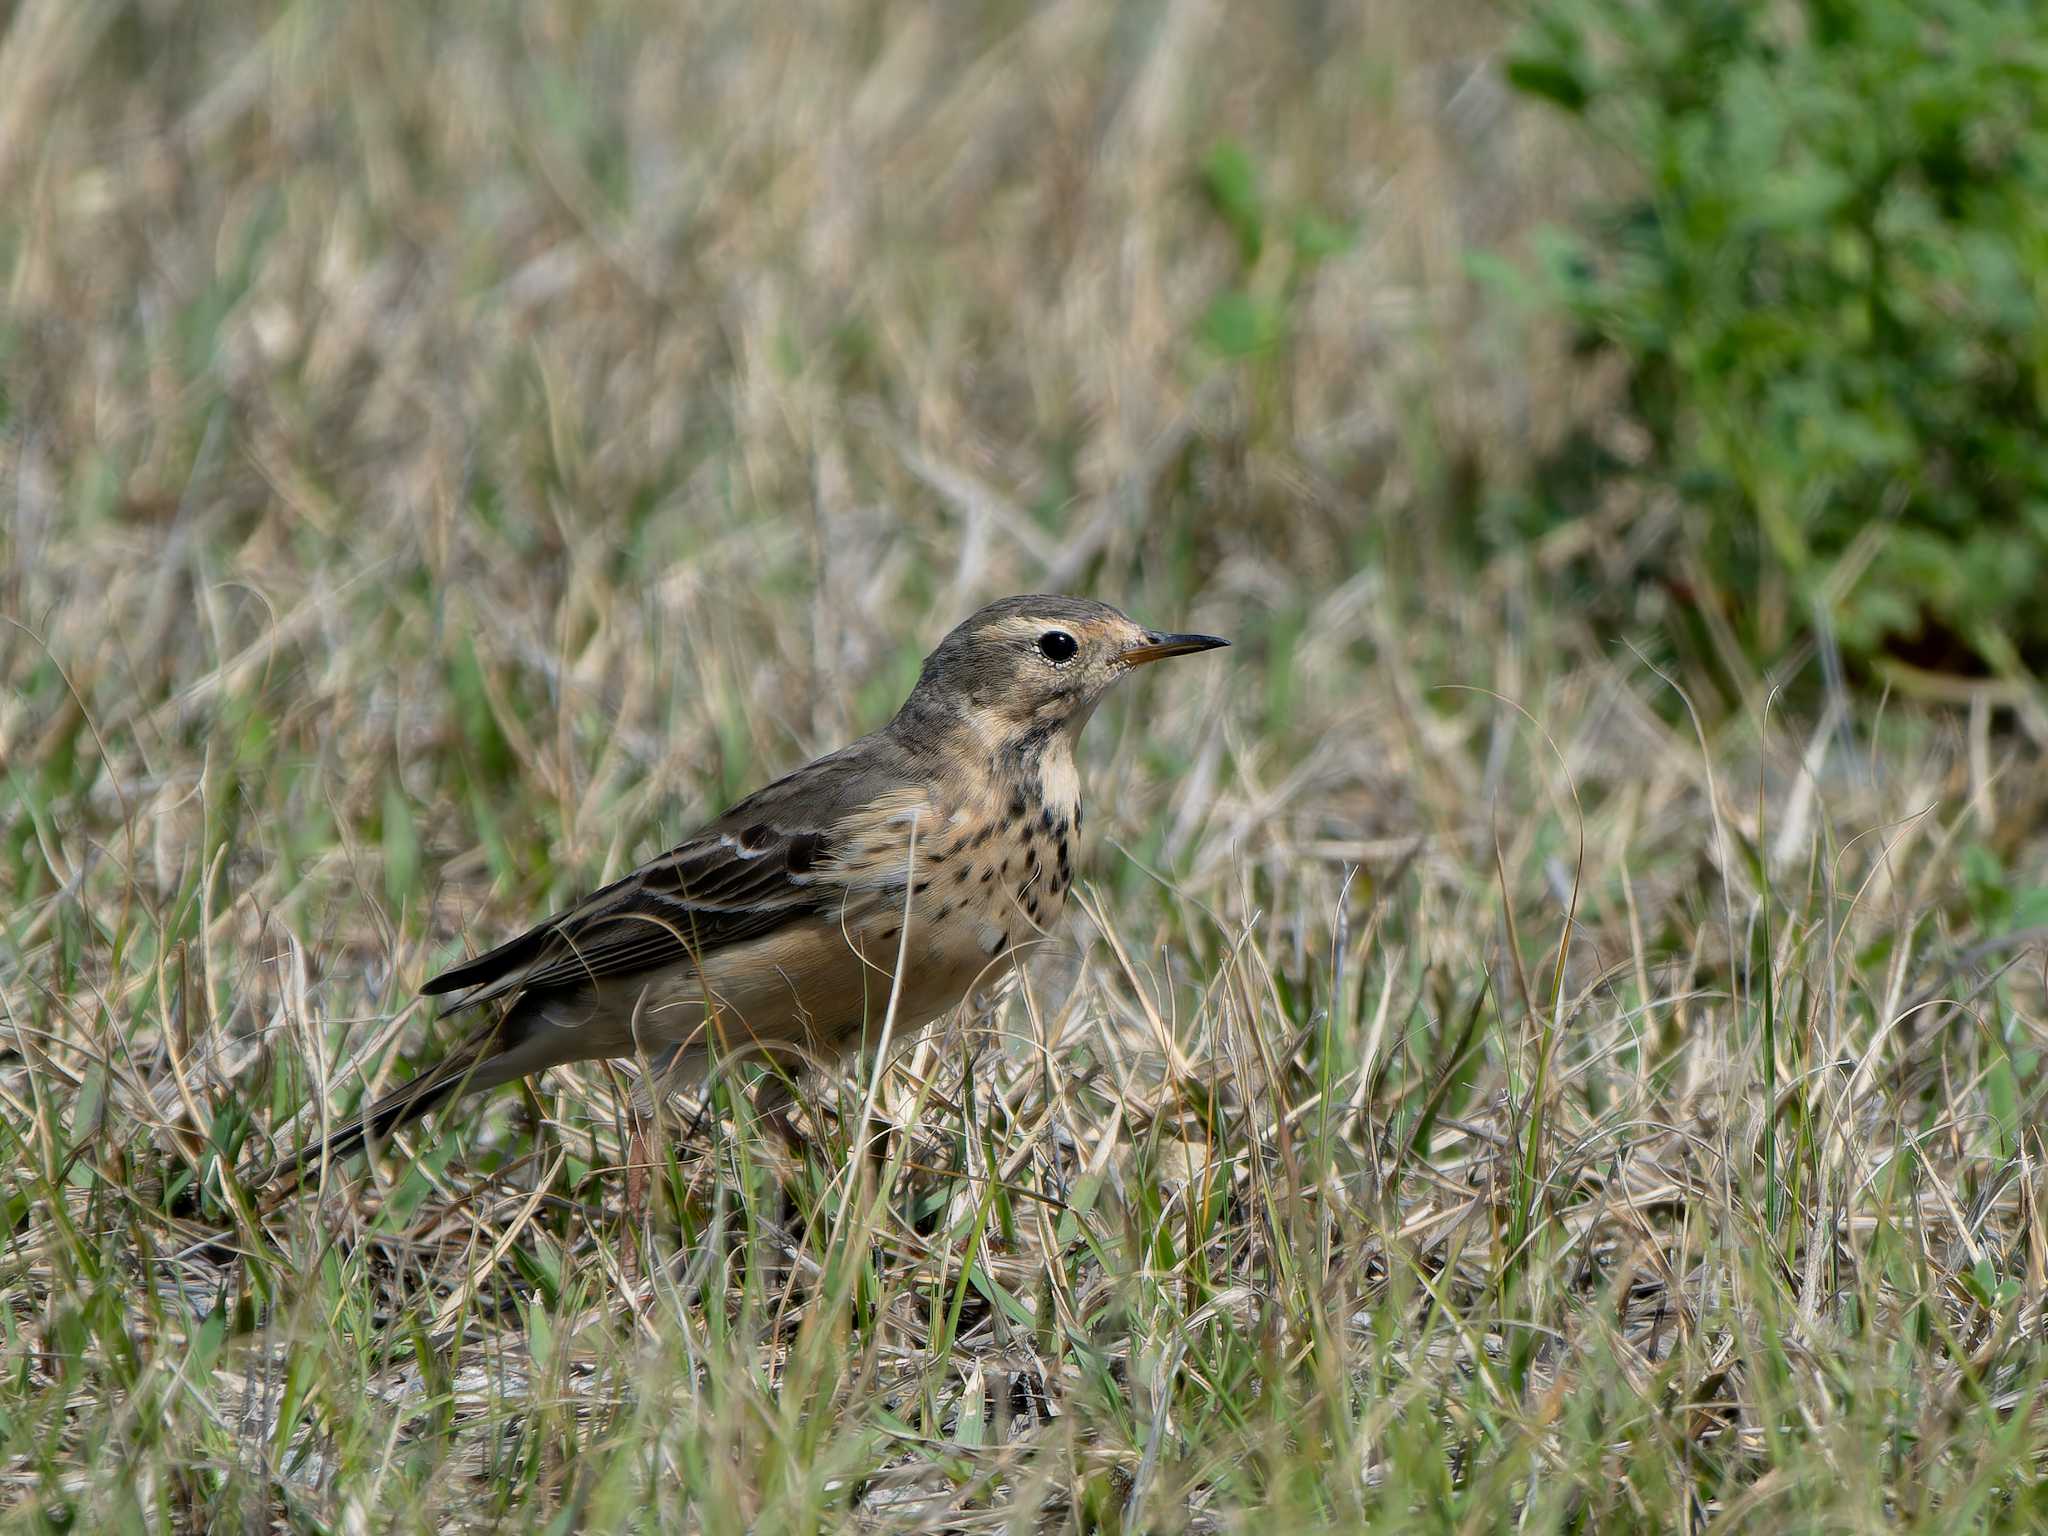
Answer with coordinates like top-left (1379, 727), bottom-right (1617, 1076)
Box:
top-left (422, 743), bottom-right (925, 1012)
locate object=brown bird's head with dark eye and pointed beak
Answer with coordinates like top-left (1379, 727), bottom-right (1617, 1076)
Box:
top-left (905, 594), bottom-right (1229, 737)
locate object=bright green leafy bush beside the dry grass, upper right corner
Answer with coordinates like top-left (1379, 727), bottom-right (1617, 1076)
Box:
top-left (1507, 0), bottom-right (2048, 668)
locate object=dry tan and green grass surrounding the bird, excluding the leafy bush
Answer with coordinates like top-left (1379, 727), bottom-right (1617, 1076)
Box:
top-left (0, 0), bottom-right (2048, 1532)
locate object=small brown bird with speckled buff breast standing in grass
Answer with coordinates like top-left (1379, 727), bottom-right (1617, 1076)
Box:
top-left (272, 594), bottom-right (1229, 1176)
